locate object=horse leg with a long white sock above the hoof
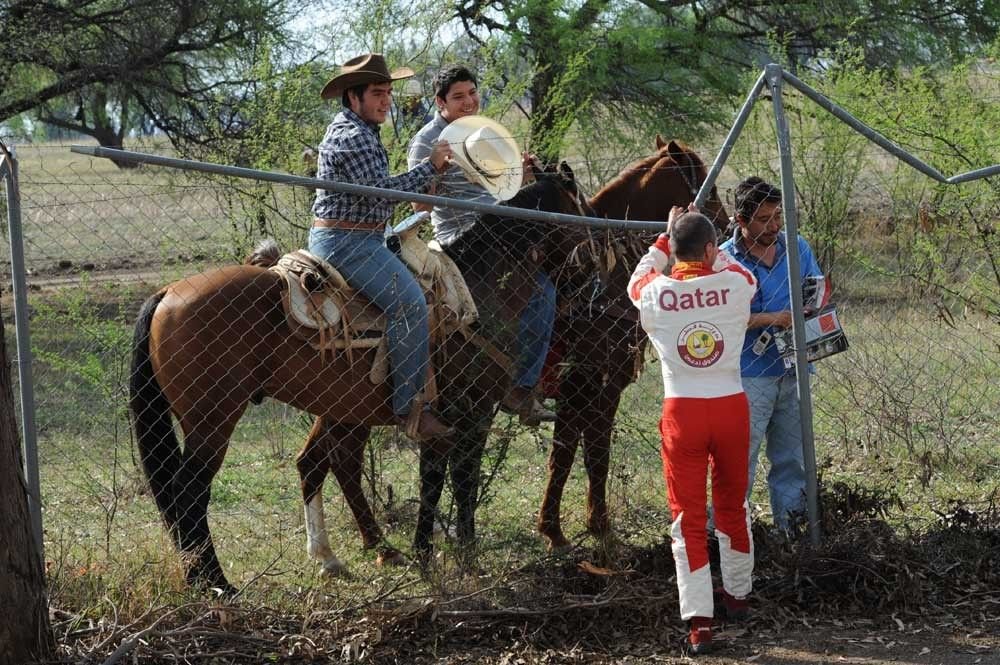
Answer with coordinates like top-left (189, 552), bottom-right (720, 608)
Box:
top-left (295, 418), bottom-right (347, 577)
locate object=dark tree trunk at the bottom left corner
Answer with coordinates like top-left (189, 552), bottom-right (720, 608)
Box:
top-left (0, 306), bottom-right (53, 665)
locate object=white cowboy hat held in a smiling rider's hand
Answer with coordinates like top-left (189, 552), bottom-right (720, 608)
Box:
top-left (441, 115), bottom-right (522, 201)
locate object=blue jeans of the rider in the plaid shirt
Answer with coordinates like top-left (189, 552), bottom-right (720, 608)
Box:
top-left (309, 229), bottom-right (430, 416)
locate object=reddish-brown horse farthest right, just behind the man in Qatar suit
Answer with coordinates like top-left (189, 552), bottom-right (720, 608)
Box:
top-left (538, 135), bottom-right (729, 549)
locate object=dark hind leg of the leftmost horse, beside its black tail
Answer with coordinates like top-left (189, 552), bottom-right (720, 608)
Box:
top-left (173, 404), bottom-right (246, 593)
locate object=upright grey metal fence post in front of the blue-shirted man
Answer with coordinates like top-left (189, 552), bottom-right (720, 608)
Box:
top-left (764, 63), bottom-right (820, 545)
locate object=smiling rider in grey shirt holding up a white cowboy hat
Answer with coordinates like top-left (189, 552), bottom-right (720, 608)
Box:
top-left (409, 65), bottom-right (556, 425)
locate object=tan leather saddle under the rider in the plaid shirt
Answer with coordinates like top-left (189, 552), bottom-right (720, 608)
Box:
top-left (270, 233), bottom-right (484, 384)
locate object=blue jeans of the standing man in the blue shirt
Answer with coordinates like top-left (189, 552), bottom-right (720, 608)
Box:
top-left (743, 374), bottom-right (806, 529)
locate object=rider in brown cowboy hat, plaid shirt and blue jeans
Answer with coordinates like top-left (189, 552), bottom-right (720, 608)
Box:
top-left (309, 53), bottom-right (452, 440)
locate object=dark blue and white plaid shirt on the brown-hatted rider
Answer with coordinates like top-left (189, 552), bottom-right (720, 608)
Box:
top-left (313, 108), bottom-right (435, 222)
